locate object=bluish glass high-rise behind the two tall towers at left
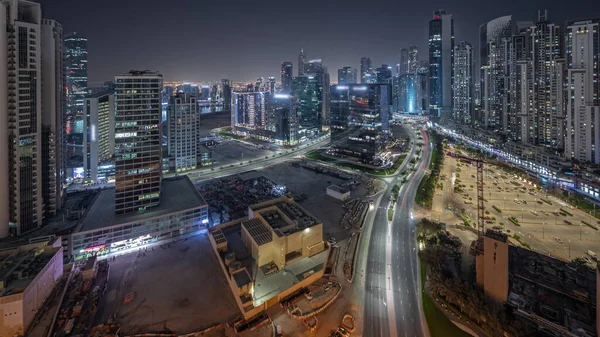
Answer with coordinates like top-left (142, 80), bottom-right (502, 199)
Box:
top-left (65, 33), bottom-right (88, 117)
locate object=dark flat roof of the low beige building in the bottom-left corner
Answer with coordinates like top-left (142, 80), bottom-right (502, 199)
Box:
top-left (0, 242), bottom-right (60, 296)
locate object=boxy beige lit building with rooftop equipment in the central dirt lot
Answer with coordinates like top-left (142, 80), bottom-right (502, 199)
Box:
top-left (209, 197), bottom-right (328, 318)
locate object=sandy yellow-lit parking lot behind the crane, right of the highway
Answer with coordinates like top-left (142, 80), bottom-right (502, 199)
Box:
top-left (432, 156), bottom-right (600, 259)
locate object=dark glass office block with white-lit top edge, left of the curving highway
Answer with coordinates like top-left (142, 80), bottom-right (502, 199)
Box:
top-left (331, 84), bottom-right (392, 162)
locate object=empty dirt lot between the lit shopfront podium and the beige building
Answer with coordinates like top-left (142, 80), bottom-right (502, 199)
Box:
top-left (96, 234), bottom-right (240, 334)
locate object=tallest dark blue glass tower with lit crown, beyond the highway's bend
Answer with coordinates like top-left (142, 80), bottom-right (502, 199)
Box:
top-left (429, 9), bottom-right (454, 118)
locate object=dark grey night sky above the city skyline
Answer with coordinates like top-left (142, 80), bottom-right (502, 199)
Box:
top-left (37, 0), bottom-right (600, 86)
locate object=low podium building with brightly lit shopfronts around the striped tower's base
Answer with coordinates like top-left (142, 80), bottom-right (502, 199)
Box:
top-left (68, 176), bottom-right (208, 260)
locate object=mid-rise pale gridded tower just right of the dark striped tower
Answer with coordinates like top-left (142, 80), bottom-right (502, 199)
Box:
top-left (167, 93), bottom-right (200, 172)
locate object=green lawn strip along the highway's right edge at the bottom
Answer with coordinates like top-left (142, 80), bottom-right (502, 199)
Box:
top-left (421, 264), bottom-right (471, 337)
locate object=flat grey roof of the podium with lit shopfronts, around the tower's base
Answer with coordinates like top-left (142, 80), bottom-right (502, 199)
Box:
top-left (76, 176), bottom-right (207, 232)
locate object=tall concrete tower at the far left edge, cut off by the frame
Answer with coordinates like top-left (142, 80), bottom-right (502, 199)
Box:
top-left (0, 0), bottom-right (45, 237)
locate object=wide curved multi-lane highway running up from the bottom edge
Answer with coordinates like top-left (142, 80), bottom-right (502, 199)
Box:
top-left (363, 126), bottom-right (431, 337)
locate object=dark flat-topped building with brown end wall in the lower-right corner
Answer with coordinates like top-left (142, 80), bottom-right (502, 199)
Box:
top-left (473, 230), bottom-right (600, 337)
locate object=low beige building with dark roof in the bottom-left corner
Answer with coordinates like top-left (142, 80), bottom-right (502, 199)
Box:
top-left (0, 237), bottom-right (63, 336)
